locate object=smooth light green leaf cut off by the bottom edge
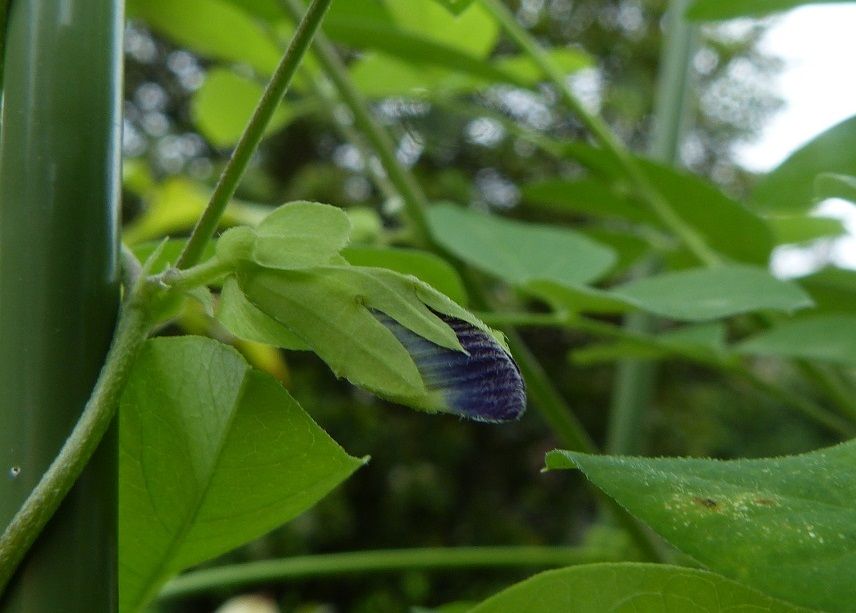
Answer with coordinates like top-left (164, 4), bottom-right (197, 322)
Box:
top-left (471, 562), bottom-right (806, 613)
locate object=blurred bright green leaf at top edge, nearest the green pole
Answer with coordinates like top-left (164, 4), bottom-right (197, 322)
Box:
top-left (128, 0), bottom-right (281, 75)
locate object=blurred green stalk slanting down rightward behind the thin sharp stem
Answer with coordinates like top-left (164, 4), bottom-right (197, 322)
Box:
top-left (281, 0), bottom-right (431, 243)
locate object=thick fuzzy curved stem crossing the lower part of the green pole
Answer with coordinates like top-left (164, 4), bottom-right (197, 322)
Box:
top-left (0, 300), bottom-right (148, 593)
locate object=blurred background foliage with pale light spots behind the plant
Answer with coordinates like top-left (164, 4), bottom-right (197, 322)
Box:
top-left (124, 0), bottom-right (829, 613)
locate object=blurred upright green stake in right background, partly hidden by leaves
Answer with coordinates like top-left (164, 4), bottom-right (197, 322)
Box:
top-left (605, 0), bottom-right (698, 455)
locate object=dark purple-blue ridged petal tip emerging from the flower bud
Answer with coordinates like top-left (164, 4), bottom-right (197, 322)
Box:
top-left (376, 313), bottom-right (526, 422)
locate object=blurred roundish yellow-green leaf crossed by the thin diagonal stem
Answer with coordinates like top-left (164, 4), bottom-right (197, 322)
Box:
top-left (190, 68), bottom-right (303, 148)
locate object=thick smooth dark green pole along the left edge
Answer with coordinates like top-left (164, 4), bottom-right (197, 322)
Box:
top-left (0, 0), bottom-right (123, 613)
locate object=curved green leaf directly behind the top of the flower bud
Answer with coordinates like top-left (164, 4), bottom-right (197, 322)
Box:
top-left (342, 247), bottom-right (467, 305)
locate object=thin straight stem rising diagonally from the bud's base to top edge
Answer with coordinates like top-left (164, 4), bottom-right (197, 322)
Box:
top-left (176, 0), bottom-right (332, 268)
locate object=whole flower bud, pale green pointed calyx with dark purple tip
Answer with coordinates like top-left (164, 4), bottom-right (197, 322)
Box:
top-left (238, 266), bottom-right (525, 421)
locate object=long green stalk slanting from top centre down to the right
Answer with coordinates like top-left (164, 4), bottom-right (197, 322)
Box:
top-left (481, 0), bottom-right (722, 266)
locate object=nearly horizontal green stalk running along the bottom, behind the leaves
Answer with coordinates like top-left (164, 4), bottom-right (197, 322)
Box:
top-left (160, 547), bottom-right (618, 601)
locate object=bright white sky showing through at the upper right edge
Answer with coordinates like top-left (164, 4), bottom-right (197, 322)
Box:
top-left (735, 3), bottom-right (856, 276)
